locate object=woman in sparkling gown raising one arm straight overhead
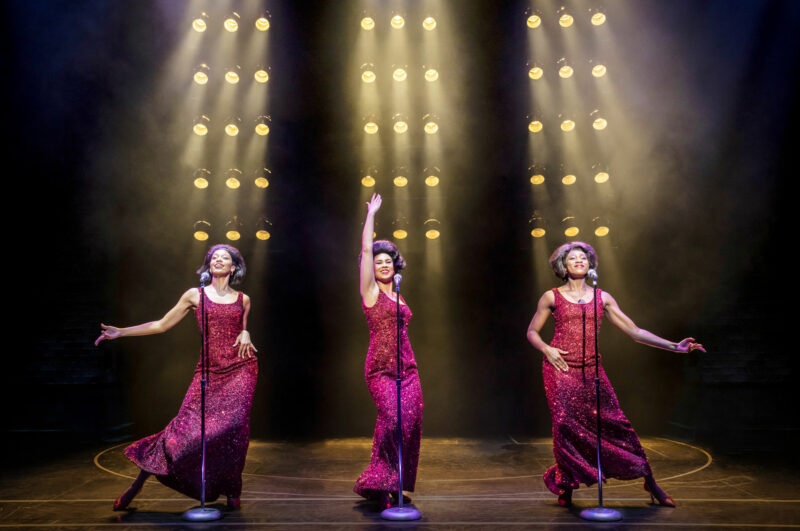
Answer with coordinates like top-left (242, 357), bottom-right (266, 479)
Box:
top-left (353, 194), bottom-right (422, 508)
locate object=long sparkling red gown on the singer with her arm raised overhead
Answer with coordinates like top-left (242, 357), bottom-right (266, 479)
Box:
top-left (353, 292), bottom-right (422, 499)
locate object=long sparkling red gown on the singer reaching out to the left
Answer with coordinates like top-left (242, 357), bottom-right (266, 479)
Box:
top-left (125, 292), bottom-right (258, 501)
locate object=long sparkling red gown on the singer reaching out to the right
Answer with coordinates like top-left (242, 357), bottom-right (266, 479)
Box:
top-left (542, 289), bottom-right (651, 494)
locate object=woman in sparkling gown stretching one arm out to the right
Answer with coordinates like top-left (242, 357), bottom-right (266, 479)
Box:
top-left (528, 242), bottom-right (705, 507)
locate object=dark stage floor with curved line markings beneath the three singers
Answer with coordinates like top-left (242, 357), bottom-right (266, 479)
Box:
top-left (0, 437), bottom-right (800, 529)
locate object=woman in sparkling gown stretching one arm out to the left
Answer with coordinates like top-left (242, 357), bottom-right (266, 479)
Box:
top-left (95, 245), bottom-right (258, 511)
